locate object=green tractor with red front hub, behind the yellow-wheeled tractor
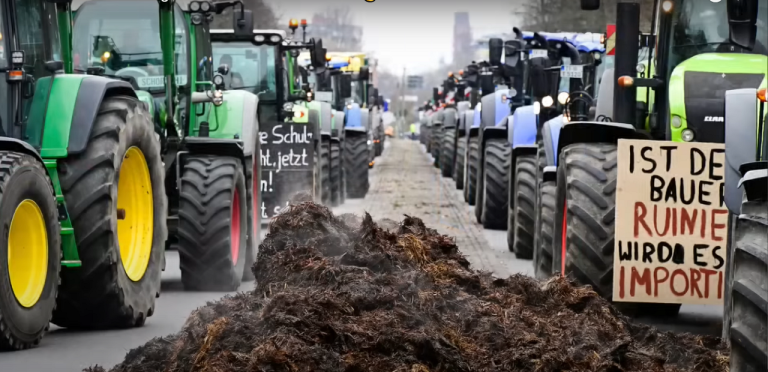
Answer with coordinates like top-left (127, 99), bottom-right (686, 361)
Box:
top-left (73, 0), bottom-right (259, 291)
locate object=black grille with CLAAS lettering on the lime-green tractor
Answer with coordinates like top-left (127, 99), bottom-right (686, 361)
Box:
top-left (684, 71), bottom-right (764, 143)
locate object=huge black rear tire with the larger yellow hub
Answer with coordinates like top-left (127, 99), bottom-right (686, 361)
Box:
top-left (52, 96), bottom-right (168, 329)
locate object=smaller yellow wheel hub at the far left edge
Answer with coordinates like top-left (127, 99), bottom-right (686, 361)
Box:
top-left (8, 199), bottom-right (48, 308)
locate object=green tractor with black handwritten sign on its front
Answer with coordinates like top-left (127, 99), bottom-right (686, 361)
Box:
top-left (211, 21), bottom-right (324, 215)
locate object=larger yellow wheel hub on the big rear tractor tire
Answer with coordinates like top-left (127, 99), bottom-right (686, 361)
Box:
top-left (117, 147), bottom-right (154, 282)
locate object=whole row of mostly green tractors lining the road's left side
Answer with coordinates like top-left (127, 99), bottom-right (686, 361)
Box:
top-left (0, 0), bottom-right (384, 350)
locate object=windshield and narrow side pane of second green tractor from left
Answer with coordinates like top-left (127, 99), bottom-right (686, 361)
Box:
top-left (72, 1), bottom-right (189, 91)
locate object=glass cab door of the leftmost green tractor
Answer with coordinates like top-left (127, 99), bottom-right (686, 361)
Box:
top-left (5, 0), bottom-right (61, 150)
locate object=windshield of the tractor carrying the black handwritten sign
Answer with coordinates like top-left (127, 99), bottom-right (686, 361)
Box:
top-left (213, 41), bottom-right (277, 101)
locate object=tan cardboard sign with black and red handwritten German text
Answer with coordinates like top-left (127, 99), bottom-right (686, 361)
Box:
top-left (613, 140), bottom-right (729, 304)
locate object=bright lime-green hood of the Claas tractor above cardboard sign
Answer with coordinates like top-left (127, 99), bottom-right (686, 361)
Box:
top-left (669, 53), bottom-right (768, 143)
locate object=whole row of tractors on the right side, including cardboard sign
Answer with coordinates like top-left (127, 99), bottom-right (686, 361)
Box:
top-left (420, 0), bottom-right (768, 371)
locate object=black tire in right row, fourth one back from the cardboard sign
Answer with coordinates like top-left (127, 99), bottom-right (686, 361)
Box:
top-left (475, 138), bottom-right (512, 230)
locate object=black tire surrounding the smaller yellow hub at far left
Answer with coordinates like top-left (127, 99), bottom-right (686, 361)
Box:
top-left (0, 160), bottom-right (61, 343)
